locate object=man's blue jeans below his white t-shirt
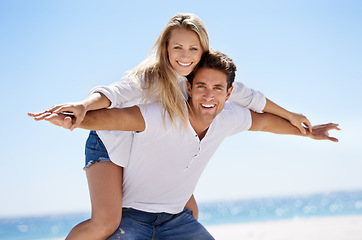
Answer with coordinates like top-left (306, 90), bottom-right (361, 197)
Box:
top-left (107, 208), bottom-right (214, 240)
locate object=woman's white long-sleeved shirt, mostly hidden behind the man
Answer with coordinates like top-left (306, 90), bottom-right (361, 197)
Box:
top-left (89, 76), bottom-right (266, 167)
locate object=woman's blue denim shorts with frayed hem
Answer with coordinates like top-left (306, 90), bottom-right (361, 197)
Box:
top-left (83, 131), bottom-right (111, 170)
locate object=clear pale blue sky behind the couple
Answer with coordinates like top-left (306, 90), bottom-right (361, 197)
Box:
top-left (0, 0), bottom-right (362, 217)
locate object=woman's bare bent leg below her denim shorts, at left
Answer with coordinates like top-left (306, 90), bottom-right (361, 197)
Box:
top-left (66, 162), bottom-right (123, 240)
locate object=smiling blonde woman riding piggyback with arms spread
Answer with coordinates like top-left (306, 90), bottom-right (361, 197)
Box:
top-left (30, 14), bottom-right (310, 239)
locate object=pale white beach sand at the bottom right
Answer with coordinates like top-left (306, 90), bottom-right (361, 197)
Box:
top-left (206, 215), bottom-right (362, 240)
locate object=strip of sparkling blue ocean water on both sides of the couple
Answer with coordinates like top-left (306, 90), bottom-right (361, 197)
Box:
top-left (0, 190), bottom-right (362, 240)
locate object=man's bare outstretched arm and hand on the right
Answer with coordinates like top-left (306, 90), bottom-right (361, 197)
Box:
top-left (249, 111), bottom-right (340, 142)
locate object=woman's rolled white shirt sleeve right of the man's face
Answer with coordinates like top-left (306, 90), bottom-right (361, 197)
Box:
top-left (229, 82), bottom-right (266, 112)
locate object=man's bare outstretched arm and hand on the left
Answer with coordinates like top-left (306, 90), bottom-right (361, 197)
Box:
top-left (28, 106), bottom-right (145, 132)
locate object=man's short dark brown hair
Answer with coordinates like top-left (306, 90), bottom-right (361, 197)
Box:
top-left (187, 51), bottom-right (236, 89)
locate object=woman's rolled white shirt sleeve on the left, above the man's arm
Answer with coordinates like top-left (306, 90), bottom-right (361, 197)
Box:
top-left (89, 77), bottom-right (142, 107)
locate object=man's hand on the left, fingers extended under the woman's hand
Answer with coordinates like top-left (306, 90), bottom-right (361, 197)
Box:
top-left (28, 112), bottom-right (74, 129)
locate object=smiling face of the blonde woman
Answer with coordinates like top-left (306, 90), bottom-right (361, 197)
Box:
top-left (167, 28), bottom-right (203, 76)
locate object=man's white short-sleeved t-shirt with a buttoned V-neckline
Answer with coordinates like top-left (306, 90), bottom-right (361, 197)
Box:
top-left (122, 102), bottom-right (251, 214)
